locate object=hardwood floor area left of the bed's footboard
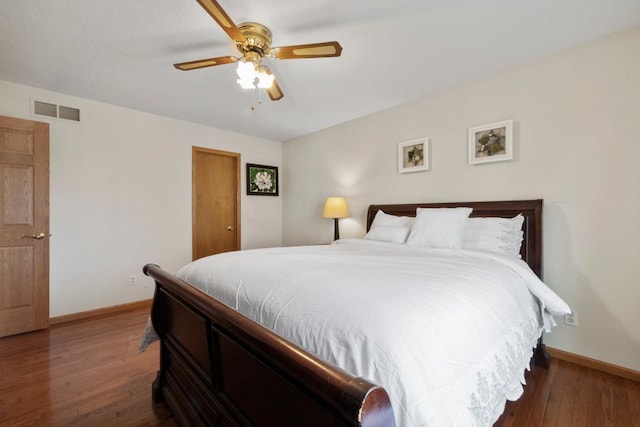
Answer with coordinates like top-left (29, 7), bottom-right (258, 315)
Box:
top-left (0, 307), bottom-right (177, 426)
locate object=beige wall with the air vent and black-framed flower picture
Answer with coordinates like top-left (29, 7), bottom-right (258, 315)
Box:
top-left (0, 81), bottom-right (282, 316)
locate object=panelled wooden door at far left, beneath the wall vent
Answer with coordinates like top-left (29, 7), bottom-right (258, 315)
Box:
top-left (0, 116), bottom-right (49, 336)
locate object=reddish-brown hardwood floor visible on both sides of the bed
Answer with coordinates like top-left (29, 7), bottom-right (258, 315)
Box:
top-left (0, 307), bottom-right (640, 427)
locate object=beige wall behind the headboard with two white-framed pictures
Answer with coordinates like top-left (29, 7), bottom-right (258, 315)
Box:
top-left (282, 28), bottom-right (640, 370)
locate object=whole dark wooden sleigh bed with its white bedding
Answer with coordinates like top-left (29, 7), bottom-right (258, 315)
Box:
top-left (144, 200), bottom-right (569, 427)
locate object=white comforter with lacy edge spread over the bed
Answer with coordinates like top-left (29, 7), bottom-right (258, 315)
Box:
top-left (178, 239), bottom-right (569, 427)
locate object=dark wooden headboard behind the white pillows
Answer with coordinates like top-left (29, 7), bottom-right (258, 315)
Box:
top-left (367, 199), bottom-right (542, 278)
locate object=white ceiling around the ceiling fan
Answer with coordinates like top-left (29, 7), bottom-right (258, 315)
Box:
top-left (0, 0), bottom-right (640, 141)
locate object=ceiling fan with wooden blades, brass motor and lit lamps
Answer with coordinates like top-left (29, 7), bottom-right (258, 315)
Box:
top-left (173, 0), bottom-right (342, 101)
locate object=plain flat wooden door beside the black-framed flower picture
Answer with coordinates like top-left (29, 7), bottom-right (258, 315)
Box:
top-left (192, 147), bottom-right (240, 260)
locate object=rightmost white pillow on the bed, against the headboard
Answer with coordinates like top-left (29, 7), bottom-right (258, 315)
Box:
top-left (462, 214), bottom-right (524, 257)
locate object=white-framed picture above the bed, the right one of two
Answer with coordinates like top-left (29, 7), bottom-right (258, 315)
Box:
top-left (469, 120), bottom-right (513, 165)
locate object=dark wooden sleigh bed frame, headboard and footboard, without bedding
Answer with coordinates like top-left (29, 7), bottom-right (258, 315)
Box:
top-left (144, 200), bottom-right (549, 427)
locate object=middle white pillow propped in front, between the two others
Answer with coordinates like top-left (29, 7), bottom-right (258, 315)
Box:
top-left (407, 208), bottom-right (472, 249)
